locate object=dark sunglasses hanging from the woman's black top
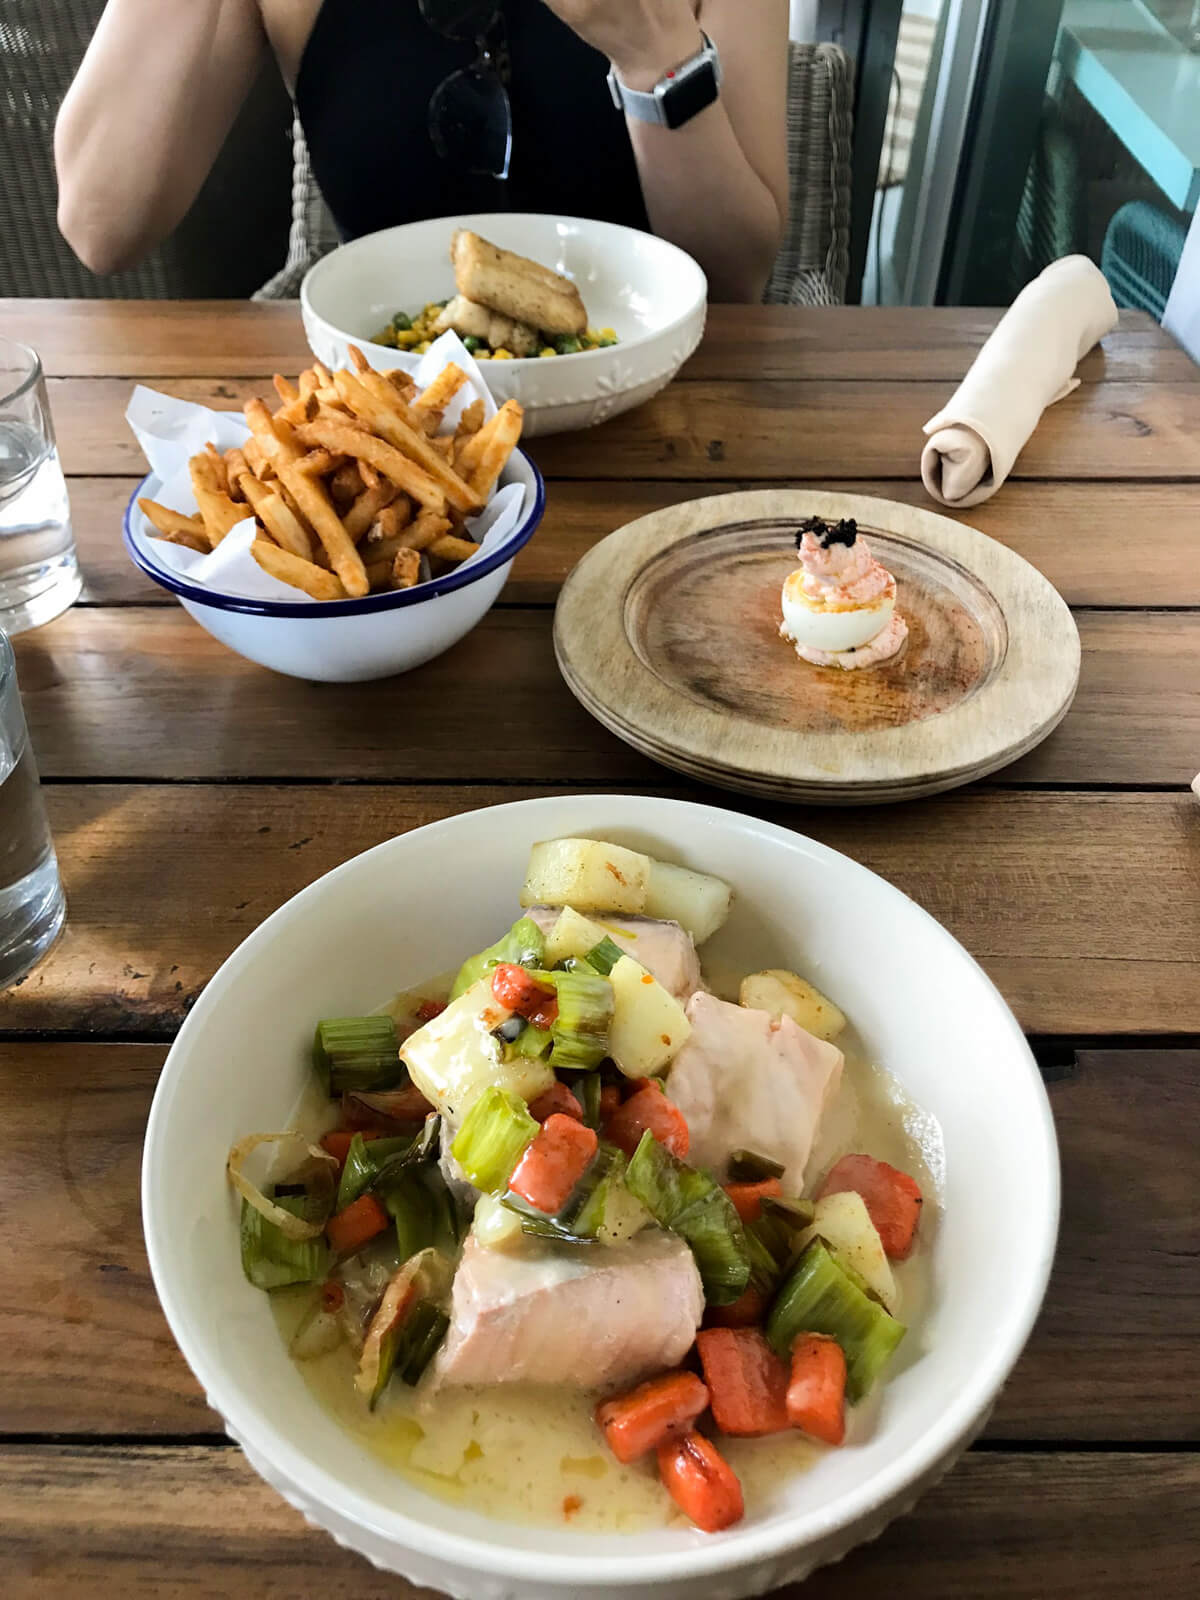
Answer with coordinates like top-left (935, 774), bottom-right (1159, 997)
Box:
top-left (418, 0), bottom-right (512, 178)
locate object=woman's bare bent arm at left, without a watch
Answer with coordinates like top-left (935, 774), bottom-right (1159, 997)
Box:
top-left (54, 0), bottom-right (266, 272)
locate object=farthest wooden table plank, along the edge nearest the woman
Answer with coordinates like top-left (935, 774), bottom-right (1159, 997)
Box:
top-left (0, 299), bottom-right (1200, 384)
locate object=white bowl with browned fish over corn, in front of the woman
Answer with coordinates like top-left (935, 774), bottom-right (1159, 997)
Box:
top-left (301, 211), bottom-right (707, 435)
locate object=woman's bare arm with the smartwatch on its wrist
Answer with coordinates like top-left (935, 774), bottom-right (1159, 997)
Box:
top-left (546, 0), bottom-right (787, 301)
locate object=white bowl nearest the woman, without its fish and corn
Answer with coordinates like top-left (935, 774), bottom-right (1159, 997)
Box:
top-left (301, 211), bottom-right (707, 438)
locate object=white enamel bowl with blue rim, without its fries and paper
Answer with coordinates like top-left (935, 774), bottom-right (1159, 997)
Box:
top-left (125, 450), bottom-right (546, 683)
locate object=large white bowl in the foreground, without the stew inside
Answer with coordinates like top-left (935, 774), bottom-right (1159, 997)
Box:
top-left (142, 795), bottom-right (1058, 1600)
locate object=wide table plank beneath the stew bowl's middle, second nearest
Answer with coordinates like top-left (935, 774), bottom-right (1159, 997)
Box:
top-left (0, 1042), bottom-right (1200, 1446)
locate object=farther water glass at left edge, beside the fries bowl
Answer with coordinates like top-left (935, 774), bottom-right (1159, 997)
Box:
top-left (0, 339), bottom-right (80, 634)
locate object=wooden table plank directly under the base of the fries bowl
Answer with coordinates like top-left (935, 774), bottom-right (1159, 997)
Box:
top-left (16, 606), bottom-right (1200, 786)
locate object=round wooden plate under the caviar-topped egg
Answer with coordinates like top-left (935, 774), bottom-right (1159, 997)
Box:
top-left (554, 490), bottom-right (1080, 805)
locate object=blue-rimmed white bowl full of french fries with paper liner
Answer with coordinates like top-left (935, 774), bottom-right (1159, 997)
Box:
top-left (125, 344), bottom-right (544, 682)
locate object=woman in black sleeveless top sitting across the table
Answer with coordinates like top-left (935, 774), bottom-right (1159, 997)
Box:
top-left (56, 0), bottom-right (787, 301)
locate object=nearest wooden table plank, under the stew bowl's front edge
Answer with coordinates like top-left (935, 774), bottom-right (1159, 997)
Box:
top-left (0, 1445), bottom-right (1200, 1600)
